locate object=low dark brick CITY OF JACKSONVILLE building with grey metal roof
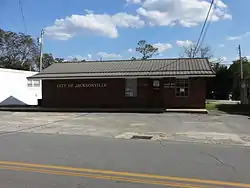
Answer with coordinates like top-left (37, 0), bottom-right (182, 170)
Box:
top-left (28, 58), bottom-right (214, 108)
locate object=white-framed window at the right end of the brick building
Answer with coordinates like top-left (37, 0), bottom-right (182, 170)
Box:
top-left (175, 79), bottom-right (189, 97)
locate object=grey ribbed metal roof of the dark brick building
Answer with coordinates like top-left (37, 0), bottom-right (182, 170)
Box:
top-left (28, 58), bottom-right (215, 79)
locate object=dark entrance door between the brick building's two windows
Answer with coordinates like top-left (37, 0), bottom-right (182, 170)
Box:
top-left (150, 80), bottom-right (163, 108)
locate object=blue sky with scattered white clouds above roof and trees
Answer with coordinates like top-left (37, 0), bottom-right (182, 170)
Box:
top-left (0, 0), bottom-right (250, 61)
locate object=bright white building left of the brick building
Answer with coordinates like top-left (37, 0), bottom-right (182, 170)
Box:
top-left (0, 68), bottom-right (42, 106)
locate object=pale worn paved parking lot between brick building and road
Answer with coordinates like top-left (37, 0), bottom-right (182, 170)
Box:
top-left (0, 112), bottom-right (250, 145)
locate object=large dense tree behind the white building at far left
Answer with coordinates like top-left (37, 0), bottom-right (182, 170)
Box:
top-left (0, 29), bottom-right (39, 70)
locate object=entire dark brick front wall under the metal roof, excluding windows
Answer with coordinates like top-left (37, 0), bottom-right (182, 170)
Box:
top-left (42, 78), bottom-right (206, 108)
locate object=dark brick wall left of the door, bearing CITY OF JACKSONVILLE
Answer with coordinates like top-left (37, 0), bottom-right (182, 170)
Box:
top-left (42, 79), bottom-right (149, 108)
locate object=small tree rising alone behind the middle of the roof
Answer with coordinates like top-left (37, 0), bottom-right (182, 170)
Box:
top-left (135, 40), bottom-right (158, 60)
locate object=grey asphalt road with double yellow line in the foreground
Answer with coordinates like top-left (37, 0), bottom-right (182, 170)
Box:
top-left (0, 133), bottom-right (250, 188)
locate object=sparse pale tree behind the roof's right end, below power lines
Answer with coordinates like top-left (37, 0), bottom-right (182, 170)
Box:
top-left (182, 43), bottom-right (213, 59)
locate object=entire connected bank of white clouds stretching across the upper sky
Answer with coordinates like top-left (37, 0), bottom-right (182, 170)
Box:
top-left (45, 0), bottom-right (232, 40)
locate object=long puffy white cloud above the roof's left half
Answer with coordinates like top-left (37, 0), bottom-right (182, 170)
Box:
top-left (45, 10), bottom-right (144, 40)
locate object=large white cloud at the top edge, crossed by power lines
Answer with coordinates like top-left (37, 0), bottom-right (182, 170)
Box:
top-left (137, 0), bottom-right (232, 27)
